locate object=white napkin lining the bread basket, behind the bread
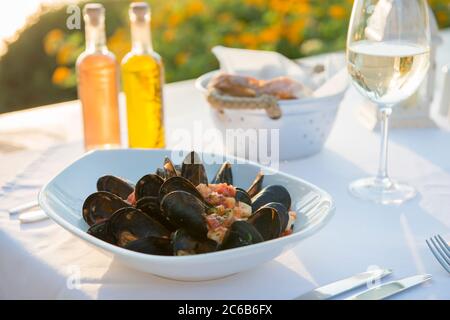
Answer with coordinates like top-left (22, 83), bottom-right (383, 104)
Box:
top-left (212, 46), bottom-right (346, 97)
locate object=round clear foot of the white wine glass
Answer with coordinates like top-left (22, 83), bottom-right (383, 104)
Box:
top-left (349, 177), bottom-right (417, 204)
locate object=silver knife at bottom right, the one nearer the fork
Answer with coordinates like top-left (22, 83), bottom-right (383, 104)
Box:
top-left (346, 274), bottom-right (431, 300)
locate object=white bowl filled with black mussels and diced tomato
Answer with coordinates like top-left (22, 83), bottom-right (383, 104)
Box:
top-left (39, 149), bottom-right (334, 281)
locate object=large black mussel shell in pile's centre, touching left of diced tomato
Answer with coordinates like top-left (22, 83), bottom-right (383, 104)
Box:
top-left (161, 190), bottom-right (208, 240)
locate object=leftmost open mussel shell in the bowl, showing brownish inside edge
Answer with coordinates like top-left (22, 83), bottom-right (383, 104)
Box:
top-left (82, 191), bottom-right (130, 226)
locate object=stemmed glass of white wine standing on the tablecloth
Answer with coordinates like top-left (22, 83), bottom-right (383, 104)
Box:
top-left (347, 0), bottom-right (431, 204)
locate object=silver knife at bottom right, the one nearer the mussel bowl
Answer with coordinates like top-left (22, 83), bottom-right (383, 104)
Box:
top-left (295, 269), bottom-right (392, 300)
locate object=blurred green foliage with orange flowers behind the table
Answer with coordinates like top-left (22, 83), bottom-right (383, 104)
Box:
top-left (0, 0), bottom-right (450, 113)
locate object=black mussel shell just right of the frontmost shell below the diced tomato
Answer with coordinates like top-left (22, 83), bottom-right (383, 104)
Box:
top-left (247, 207), bottom-right (281, 241)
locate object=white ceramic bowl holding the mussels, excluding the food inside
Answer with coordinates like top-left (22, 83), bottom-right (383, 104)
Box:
top-left (39, 149), bottom-right (333, 281)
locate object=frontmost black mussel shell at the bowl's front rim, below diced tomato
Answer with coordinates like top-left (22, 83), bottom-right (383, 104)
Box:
top-left (219, 220), bottom-right (264, 250)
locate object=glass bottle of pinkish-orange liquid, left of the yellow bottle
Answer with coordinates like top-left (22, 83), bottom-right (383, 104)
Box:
top-left (76, 3), bottom-right (120, 150)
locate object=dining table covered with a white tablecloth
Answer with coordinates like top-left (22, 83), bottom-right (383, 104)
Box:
top-left (0, 30), bottom-right (450, 300)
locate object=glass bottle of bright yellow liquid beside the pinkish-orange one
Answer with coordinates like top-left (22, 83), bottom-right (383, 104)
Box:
top-left (122, 2), bottom-right (165, 148)
